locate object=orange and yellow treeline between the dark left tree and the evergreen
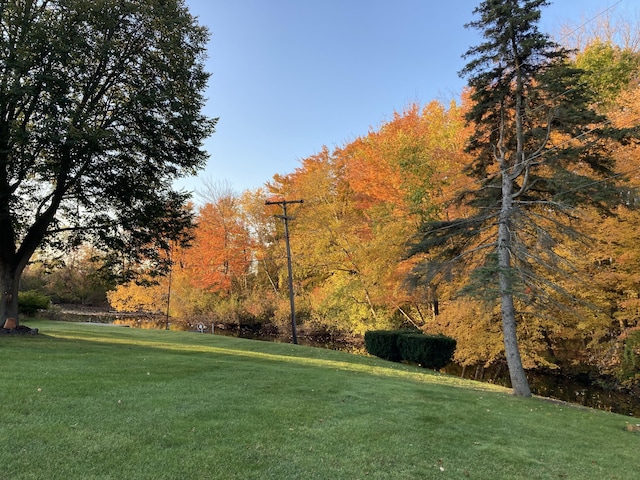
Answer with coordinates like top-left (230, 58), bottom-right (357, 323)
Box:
top-left (109, 102), bottom-right (465, 336)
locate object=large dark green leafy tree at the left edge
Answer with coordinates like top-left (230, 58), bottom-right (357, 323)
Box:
top-left (0, 0), bottom-right (215, 321)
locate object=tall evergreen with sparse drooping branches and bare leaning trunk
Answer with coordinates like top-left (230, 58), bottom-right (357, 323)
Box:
top-left (412, 0), bottom-right (630, 396)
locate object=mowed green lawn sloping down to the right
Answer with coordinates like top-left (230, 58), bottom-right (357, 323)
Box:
top-left (0, 321), bottom-right (640, 480)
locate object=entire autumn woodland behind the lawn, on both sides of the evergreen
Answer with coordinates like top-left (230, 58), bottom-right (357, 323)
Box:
top-left (22, 15), bottom-right (640, 387)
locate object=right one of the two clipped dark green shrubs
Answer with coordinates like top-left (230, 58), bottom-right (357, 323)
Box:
top-left (398, 333), bottom-right (456, 370)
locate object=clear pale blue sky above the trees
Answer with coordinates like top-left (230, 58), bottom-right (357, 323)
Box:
top-left (177, 0), bottom-right (638, 192)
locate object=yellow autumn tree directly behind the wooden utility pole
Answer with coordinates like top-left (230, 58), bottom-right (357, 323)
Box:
top-left (264, 147), bottom-right (358, 329)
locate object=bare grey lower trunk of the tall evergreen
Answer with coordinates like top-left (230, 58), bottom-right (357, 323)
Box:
top-left (498, 170), bottom-right (531, 397)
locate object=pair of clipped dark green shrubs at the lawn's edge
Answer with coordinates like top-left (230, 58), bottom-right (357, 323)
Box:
top-left (364, 330), bottom-right (456, 370)
